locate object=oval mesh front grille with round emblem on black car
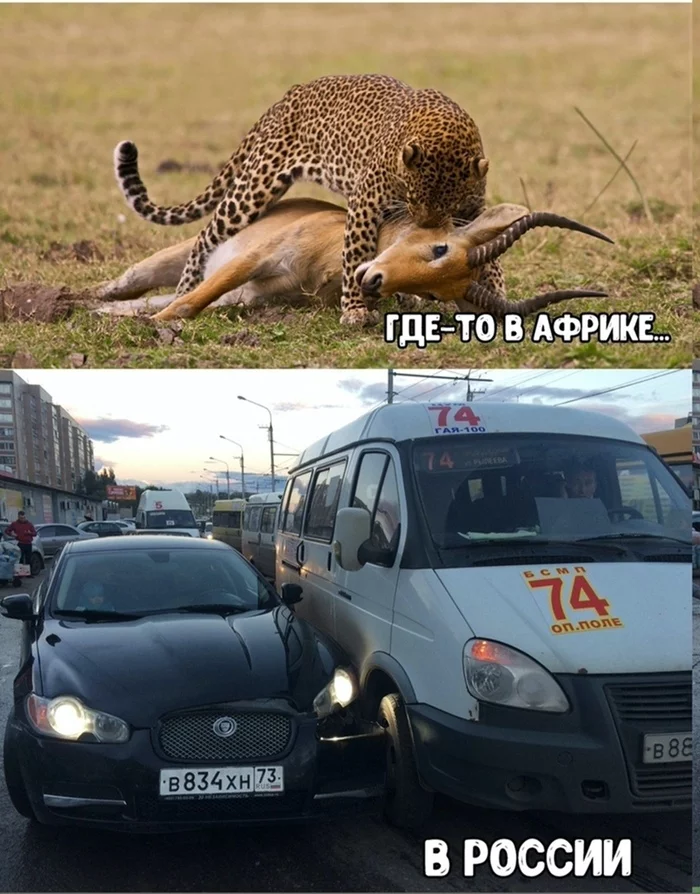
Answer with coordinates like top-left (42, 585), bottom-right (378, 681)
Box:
top-left (158, 709), bottom-right (293, 763)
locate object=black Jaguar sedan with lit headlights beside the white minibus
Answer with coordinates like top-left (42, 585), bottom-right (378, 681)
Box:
top-left (0, 536), bottom-right (385, 831)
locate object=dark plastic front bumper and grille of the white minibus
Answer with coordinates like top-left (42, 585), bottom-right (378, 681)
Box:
top-left (407, 674), bottom-right (692, 813)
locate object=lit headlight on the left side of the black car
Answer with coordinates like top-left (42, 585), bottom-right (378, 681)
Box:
top-left (27, 692), bottom-right (130, 743)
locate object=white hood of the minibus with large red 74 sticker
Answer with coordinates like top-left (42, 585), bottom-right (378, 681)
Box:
top-left (436, 562), bottom-right (692, 674)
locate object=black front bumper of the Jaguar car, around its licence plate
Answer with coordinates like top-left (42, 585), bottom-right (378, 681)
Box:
top-left (9, 718), bottom-right (384, 832)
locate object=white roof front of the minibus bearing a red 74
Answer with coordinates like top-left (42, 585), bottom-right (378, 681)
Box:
top-left (290, 401), bottom-right (645, 472)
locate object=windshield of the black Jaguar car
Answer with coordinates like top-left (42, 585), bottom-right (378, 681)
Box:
top-left (51, 546), bottom-right (278, 617)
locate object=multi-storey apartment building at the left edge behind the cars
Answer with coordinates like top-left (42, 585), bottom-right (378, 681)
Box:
top-left (0, 369), bottom-right (95, 492)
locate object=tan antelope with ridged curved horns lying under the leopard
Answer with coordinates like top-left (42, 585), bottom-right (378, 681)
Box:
top-left (97, 199), bottom-right (612, 320)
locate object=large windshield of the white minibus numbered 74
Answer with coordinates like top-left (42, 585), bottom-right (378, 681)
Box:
top-left (413, 434), bottom-right (691, 560)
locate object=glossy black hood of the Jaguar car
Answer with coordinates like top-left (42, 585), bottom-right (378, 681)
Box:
top-left (37, 606), bottom-right (339, 727)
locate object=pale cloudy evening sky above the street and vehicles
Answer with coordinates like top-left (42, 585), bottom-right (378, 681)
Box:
top-left (20, 369), bottom-right (691, 484)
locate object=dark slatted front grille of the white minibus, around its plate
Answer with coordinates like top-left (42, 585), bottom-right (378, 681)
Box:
top-left (605, 674), bottom-right (692, 807)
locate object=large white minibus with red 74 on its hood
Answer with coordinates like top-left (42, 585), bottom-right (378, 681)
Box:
top-left (276, 402), bottom-right (692, 827)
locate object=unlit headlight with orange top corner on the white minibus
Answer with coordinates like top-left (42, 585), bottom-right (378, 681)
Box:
top-left (463, 639), bottom-right (569, 713)
